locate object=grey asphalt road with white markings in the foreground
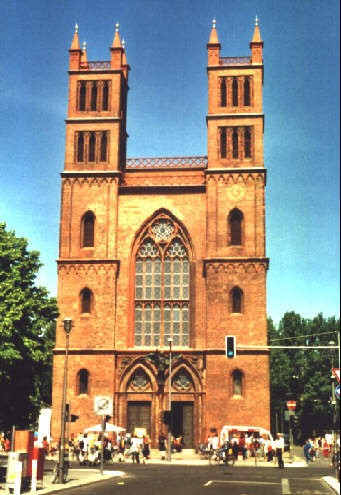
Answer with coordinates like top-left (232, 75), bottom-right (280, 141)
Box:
top-left (58, 464), bottom-right (334, 495)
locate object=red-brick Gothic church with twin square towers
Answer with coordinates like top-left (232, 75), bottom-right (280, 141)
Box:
top-left (52, 19), bottom-right (270, 448)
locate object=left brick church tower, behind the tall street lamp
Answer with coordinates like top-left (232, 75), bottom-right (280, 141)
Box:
top-left (53, 24), bottom-right (129, 432)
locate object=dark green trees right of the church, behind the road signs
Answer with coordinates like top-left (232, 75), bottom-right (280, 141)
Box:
top-left (268, 312), bottom-right (340, 441)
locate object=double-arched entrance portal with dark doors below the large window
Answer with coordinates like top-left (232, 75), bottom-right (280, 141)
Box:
top-left (115, 351), bottom-right (202, 449)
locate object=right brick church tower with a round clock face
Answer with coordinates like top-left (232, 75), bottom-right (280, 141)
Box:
top-left (204, 18), bottom-right (269, 424)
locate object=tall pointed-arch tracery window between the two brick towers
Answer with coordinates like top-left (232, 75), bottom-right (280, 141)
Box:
top-left (134, 216), bottom-right (189, 347)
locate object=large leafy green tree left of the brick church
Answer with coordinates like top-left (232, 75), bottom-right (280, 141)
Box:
top-left (0, 223), bottom-right (58, 430)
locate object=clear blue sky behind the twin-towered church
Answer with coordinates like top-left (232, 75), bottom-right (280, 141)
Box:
top-left (0, 0), bottom-right (340, 322)
